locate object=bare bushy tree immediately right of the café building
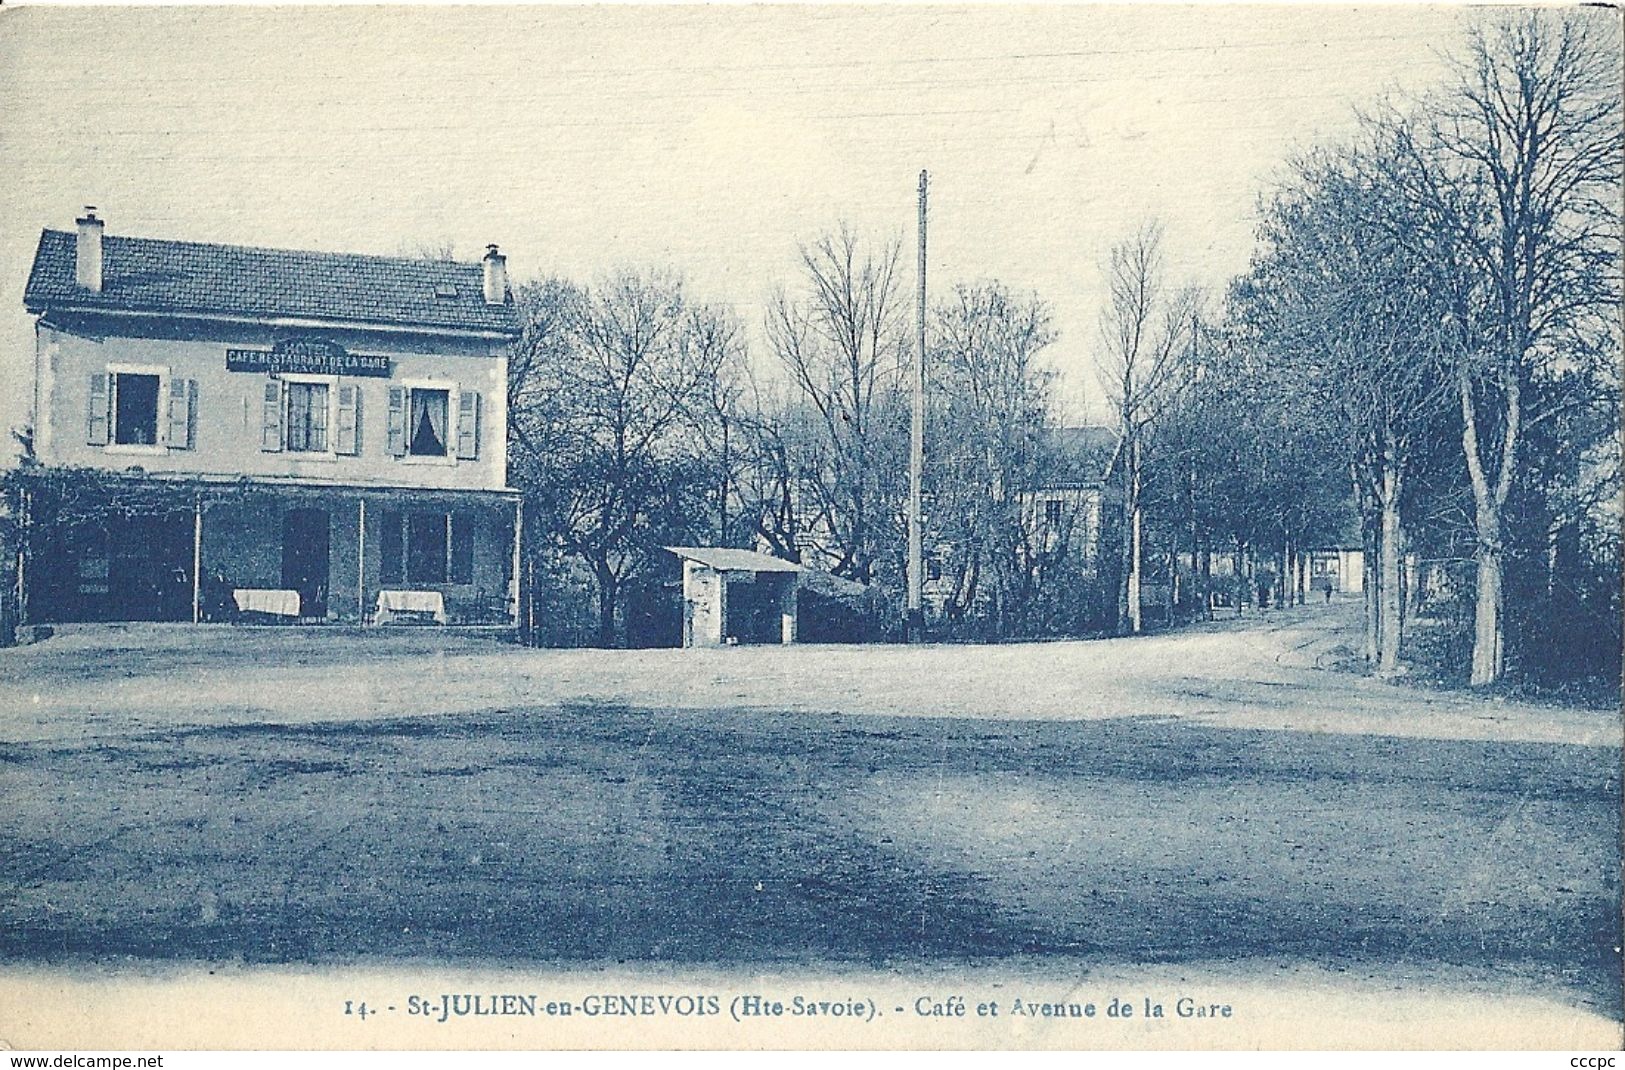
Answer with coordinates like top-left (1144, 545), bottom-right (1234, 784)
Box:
top-left (510, 272), bottom-right (736, 646)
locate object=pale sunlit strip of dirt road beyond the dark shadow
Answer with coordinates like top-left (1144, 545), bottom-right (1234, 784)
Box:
top-left (0, 602), bottom-right (1620, 748)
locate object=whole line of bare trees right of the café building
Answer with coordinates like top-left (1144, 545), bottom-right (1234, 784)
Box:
top-left (510, 11), bottom-right (1620, 695)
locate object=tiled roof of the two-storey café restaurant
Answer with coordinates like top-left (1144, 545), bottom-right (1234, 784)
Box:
top-left (23, 229), bottom-right (518, 335)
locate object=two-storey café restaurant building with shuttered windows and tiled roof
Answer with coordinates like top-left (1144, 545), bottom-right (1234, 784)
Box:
top-left (21, 208), bottom-right (522, 626)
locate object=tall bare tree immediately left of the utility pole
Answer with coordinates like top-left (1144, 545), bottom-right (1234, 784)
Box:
top-left (767, 219), bottom-right (908, 582)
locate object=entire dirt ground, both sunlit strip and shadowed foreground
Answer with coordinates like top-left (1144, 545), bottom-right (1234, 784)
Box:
top-left (0, 613), bottom-right (1620, 1040)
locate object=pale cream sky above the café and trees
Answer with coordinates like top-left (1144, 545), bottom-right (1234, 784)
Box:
top-left (0, 5), bottom-right (1466, 439)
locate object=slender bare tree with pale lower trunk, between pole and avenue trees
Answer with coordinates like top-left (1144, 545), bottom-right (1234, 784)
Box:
top-left (1100, 221), bottom-right (1199, 633)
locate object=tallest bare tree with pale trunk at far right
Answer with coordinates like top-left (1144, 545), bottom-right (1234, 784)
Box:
top-left (1396, 10), bottom-right (1625, 686)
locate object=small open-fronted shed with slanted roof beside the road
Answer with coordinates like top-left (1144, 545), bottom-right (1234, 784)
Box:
top-left (666, 546), bottom-right (801, 647)
